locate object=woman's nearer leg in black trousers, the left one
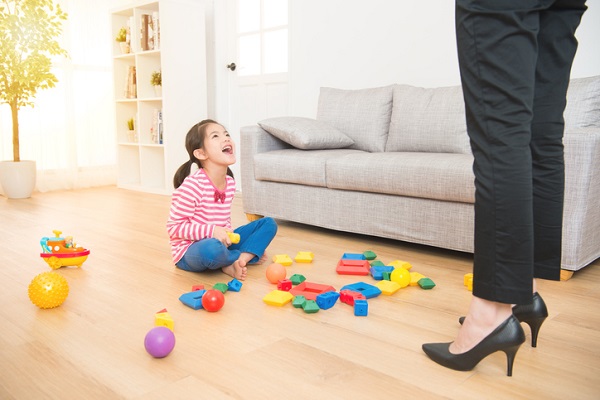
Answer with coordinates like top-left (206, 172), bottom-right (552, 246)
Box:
top-left (456, 0), bottom-right (539, 304)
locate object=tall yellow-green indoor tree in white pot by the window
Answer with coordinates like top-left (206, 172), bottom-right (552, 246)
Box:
top-left (0, 0), bottom-right (67, 198)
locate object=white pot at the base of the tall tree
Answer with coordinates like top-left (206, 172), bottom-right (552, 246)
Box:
top-left (0, 160), bottom-right (36, 199)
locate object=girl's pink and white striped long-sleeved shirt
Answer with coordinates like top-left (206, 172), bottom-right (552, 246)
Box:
top-left (167, 169), bottom-right (235, 263)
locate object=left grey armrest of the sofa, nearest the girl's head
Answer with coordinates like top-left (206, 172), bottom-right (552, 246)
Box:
top-left (240, 125), bottom-right (292, 214)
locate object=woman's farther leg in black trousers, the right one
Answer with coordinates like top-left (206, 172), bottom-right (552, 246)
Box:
top-left (530, 0), bottom-right (586, 282)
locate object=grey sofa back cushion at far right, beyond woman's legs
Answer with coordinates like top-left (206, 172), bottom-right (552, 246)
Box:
top-left (564, 75), bottom-right (600, 130)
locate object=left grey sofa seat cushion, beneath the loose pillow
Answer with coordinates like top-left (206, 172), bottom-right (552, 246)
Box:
top-left (254, 149), bottom-right (363, 187)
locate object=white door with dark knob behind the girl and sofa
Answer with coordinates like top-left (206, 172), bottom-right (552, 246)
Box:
top-left (217, 0), bottom-right (289, 183)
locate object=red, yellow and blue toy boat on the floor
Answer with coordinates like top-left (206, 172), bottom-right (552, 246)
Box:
top-left (40, 231), bottom-right (90, 269)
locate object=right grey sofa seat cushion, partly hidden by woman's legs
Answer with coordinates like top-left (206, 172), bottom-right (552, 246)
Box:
top-left (326, 152), bottom-right (475, 203)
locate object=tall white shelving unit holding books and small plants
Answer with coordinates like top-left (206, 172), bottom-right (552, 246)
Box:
top-left (111, 0), bottom-right (207, 194)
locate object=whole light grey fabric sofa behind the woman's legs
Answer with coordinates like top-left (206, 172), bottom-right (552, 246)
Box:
top-left (241, 76), bottom-right (600, 271)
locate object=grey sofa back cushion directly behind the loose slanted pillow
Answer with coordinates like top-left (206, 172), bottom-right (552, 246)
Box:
top-left (317, 85), bottom-right (393, 152)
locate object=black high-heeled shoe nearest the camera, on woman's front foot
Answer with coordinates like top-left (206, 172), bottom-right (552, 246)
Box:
top-left (423, 315), bottom-right (525, 376)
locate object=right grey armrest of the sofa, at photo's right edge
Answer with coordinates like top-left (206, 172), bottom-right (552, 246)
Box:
top-left (562, 127), bottom-right (600, 270)
